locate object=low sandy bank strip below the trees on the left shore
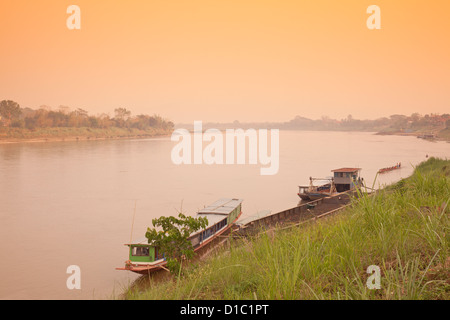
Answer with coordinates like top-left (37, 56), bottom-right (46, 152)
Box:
top-left (0, 127), bottom-right (173, 144)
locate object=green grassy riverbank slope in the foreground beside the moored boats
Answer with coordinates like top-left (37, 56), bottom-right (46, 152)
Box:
top-left (125, 158), bottom-right (450, 299)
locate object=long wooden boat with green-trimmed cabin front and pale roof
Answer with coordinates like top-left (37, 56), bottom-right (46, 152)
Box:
top-left (116, 198), bottom-right (243, 274)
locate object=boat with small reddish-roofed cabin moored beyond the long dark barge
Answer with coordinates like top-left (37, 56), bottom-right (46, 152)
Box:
top-left (297, 168), bottom-right (362, 201)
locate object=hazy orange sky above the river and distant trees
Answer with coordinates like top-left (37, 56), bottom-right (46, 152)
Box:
top-left (0, 0), bottom-right (450, 122)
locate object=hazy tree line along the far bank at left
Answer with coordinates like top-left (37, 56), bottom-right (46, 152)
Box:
top-left (0, 100), bottom-right (174, 130)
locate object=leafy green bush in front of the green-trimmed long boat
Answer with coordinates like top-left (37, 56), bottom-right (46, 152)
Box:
top-left (145, 213), bottom-right (208, 274)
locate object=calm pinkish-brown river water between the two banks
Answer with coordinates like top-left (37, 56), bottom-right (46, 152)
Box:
top-left (0, 131), bottom-right (450, 299)
